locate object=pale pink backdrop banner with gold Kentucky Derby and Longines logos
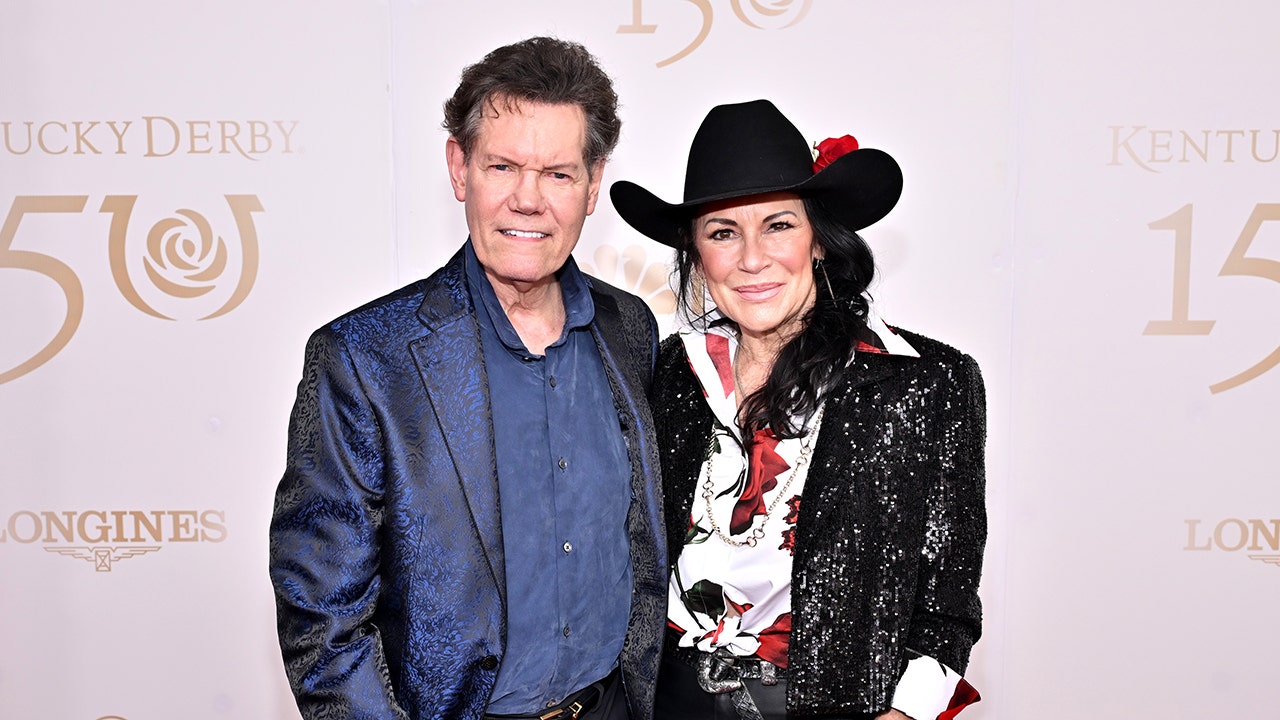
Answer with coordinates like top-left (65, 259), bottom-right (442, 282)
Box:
top-left (0, 0), bottom-right (1280, 720)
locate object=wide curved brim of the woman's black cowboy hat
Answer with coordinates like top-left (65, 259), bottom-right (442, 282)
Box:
top-left (609, 147), bottom-right (902, 247)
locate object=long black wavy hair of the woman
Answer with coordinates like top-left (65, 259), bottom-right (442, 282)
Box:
top-left (676, 197), bottom-right (876, 438)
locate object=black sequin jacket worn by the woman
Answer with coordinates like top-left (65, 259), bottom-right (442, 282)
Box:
top-left (653, 332), bottom-right (987, 715)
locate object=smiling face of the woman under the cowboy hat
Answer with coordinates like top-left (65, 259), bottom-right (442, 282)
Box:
top-left (694, 192), bottom-right (822, 342)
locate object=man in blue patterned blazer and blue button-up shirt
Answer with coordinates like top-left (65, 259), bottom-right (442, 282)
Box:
top-left (270, 37), bottom-right (666, 720)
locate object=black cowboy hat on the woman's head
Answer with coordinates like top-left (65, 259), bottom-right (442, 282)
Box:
top-left (609, 100), bottom-right (902, 247)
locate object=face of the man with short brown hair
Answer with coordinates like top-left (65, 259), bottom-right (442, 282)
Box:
top-left (445, 101), bottom-right (604, 290)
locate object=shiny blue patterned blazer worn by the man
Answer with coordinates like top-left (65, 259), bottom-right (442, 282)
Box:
top-left (270, 252), bottom-right (667, 720)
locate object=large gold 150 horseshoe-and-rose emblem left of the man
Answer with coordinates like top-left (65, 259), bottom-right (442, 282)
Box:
top-left (0, 195), bottom-right (262, 384)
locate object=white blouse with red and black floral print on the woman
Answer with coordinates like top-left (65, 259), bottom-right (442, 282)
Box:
top-left (667, 318), bottom-right (977, 720)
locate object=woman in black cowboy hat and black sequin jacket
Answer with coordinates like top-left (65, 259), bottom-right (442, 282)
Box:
top-left (611, 100), bottom-right (986, 720)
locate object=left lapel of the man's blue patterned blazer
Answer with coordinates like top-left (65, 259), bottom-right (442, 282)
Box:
top-left (410, 252), bottom-right (507, 605)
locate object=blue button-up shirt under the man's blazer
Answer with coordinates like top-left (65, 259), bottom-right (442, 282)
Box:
top-left (466, 241), bottom-right (631, 715)
